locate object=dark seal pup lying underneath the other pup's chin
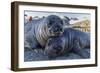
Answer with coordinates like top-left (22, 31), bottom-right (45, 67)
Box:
top-left (44, 28), bottom-right (90, 59)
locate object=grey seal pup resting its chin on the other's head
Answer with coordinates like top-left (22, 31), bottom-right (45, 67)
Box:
top-left (24, 15), bottom-right (63, 49)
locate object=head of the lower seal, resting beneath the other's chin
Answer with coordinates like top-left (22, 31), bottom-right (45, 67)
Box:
top-left (44, 37), bottom-right (63, 59)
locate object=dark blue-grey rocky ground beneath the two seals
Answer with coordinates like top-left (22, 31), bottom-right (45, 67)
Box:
top-left (24, 49), bottom-right (90, 62)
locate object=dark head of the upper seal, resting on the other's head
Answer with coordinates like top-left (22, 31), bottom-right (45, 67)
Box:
top-left (47, 15), bottom-right (63, 36)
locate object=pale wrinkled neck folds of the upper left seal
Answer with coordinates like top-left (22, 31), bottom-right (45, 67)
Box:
top-left (35, 20), bottom-right (50, 47)
